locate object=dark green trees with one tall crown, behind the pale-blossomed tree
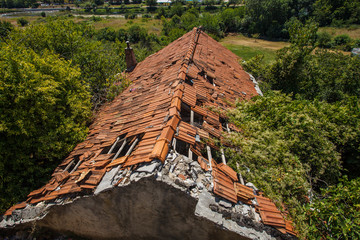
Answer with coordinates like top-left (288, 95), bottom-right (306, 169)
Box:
top-left (253, 21), bottom-right (360, 102)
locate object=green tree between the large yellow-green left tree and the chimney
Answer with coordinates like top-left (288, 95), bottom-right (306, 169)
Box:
top-left (12, 20), bottom-right (126, 108)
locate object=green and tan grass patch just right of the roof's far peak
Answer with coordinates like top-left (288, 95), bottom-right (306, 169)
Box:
top-left (220, 35), bottom-right (289, 63)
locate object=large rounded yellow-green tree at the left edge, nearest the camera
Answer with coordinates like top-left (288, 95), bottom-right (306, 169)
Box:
top-left (0, 44), bottom-right (91, 211)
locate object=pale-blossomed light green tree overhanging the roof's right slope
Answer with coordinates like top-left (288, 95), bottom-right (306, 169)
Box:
top-left (227, 92), bottom-right (360, 236)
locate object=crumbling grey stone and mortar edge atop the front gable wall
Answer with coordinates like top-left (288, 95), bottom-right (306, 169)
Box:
top-left (0, 150), bottom-right (295, 239)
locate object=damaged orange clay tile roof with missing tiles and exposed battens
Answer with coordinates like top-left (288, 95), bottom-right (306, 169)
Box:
top-left (5, 28), bottom-right (294, 237)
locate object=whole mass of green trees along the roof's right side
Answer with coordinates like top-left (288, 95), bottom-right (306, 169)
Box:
top-left (233, 20), bottom-right (360, 239)
